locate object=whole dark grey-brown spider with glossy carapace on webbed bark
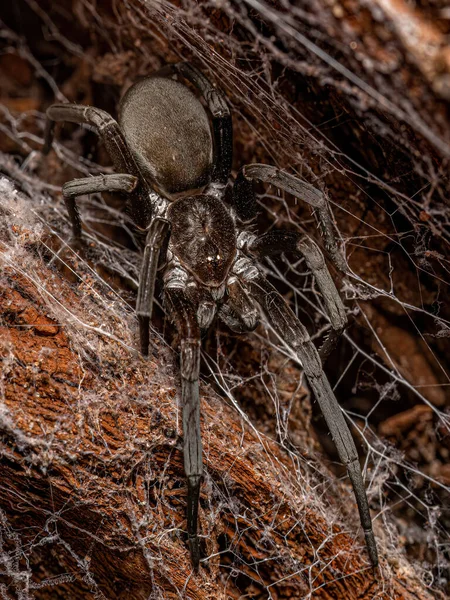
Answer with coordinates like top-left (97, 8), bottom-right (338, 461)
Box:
top-left (43, 62), bottom-right (378, 570)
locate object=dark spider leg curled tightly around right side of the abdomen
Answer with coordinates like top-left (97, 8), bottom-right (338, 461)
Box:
top-left (160, 62), bottom-right (233, 187)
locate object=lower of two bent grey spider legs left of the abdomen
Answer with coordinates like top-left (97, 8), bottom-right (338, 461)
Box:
top-left (62, 173), bottom-right (138, 242)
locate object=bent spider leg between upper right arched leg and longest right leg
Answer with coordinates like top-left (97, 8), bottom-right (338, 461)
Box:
top-left (247, 231), bottom-right (347, 363)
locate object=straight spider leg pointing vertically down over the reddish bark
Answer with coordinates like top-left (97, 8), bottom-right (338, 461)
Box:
top-left (166, 281), bottom-right (203, 570)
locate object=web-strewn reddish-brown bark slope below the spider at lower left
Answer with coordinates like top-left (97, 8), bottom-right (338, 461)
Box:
top-left (0, 241), bottom-right (431, 600)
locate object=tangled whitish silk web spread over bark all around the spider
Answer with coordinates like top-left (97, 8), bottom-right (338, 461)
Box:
top-left (0, 0), bottom-right (450, 599)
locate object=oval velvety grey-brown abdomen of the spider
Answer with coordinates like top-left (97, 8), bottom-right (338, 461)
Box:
top-left (119, 76), bottom-right (213, 194)
